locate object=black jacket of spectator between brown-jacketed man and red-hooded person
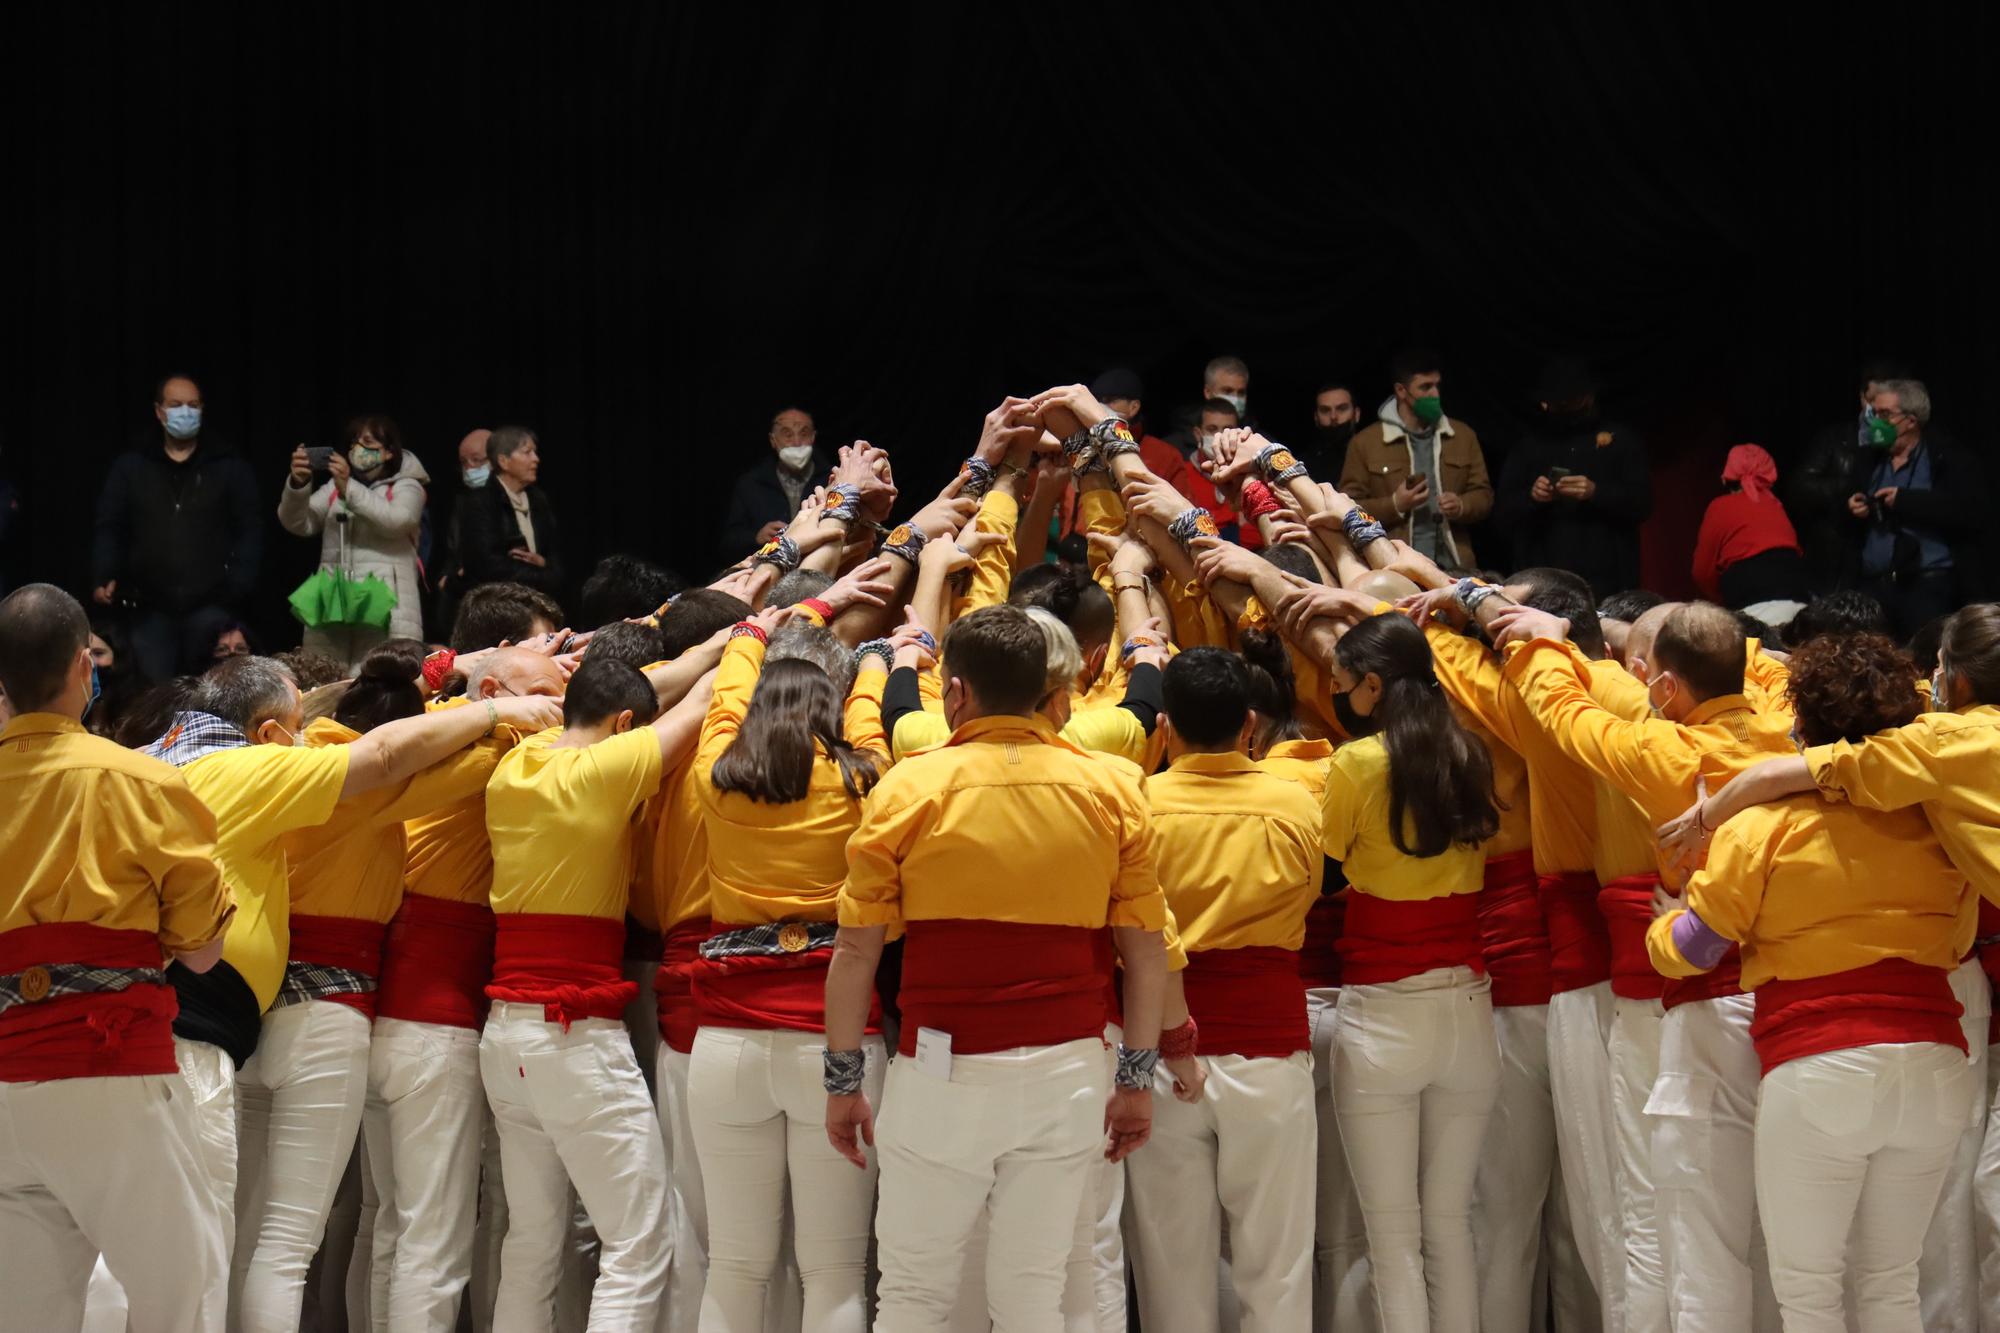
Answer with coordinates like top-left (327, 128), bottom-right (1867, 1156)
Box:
top-left (1492, 420), bottom-right (1652, 598)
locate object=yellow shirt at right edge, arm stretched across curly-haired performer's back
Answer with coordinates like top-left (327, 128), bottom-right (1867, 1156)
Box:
top-left (1808, 705), bottom-right (2000, 905)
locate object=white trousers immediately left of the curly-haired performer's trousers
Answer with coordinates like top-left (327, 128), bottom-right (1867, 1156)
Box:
top-left (1646, 995), bottom-right (1762, 1333)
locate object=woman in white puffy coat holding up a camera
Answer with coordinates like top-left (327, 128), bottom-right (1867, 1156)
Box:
top-left (278, 416), bottom-right (430, 667)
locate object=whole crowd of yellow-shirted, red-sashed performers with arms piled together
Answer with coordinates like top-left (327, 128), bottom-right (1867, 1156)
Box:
top-left (0, 376), bottom-right (2000, 1333)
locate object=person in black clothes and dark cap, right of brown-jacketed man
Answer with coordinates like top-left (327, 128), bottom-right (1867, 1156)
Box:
top-left (1494, 358), bottom-right (1652, 596)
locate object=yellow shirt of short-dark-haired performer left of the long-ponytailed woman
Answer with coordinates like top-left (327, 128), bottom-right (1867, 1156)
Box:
top-left (1146, 755), bottom-right (1326, 953)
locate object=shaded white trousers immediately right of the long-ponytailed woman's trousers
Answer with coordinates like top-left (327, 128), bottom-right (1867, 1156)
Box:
top-left (1472, 1005), bottom-right (1552, 1333)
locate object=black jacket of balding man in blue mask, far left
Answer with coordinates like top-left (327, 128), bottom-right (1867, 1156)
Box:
top-left (92, 434), bottom-right (264, 612)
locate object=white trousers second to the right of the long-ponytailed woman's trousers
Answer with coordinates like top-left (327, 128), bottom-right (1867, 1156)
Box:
top-left (1548, 981), bottom-right (1624, 1333)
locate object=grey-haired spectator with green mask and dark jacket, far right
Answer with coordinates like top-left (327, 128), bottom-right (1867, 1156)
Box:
top-left (1848, 380), bottom-right (1986, 640)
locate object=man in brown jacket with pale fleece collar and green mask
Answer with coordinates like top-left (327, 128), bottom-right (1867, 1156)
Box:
top-left (1340, 350), bottom-right (1494, 570)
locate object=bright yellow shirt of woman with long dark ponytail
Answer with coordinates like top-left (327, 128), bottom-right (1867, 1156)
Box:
top-left (1320, 737), bottom-right (1486, 903)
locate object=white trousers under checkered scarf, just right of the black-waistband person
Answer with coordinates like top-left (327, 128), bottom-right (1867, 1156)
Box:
top-left (230, 1001), bottom-right (368, 1333)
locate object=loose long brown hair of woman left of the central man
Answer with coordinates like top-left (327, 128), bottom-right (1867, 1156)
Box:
top-left (710, 658), bottom-right (880, 805)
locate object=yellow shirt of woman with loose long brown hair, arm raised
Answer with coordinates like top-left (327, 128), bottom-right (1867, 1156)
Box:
top-left (690, 634), bottom-right (862, 925)
